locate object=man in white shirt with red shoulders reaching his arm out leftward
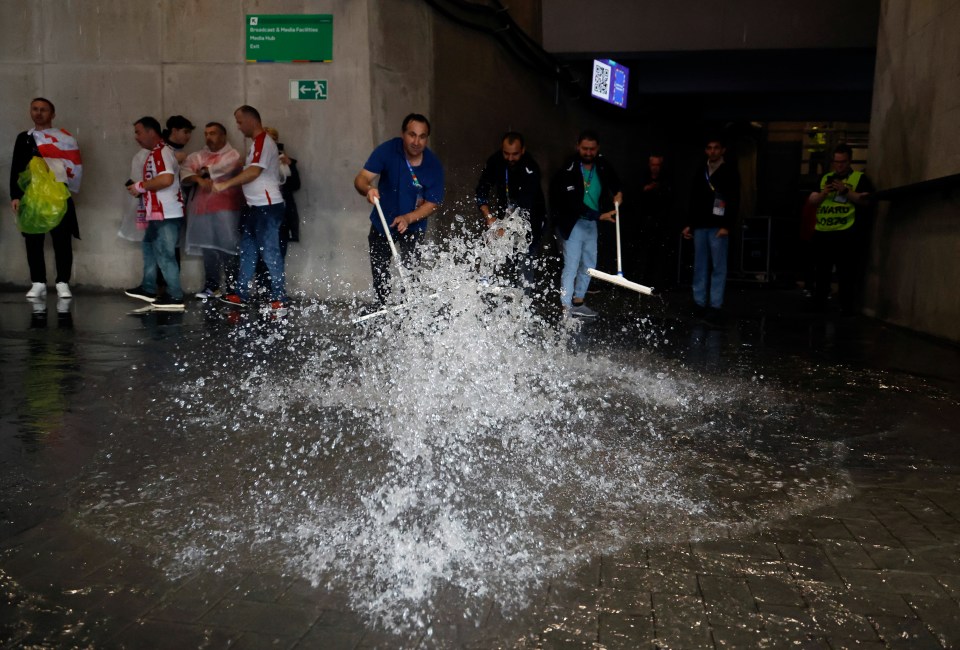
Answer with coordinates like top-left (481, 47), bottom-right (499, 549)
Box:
top-left (213, 106), bottom-right (287, 312)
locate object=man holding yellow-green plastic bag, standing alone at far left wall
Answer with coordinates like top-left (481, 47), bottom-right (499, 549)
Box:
top-left (10, 97), bottom-right (83, 299)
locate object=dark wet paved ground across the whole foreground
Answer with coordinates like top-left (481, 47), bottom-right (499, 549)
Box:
top-left (0, 286), bottom-right (960, 649)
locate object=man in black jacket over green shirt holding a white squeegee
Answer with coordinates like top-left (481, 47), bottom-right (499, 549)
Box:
top-left (550, 131), bottom-right (623, 318)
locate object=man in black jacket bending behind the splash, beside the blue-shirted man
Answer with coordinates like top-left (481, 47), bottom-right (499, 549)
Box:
top-left (475, 131), bottom-right (547, 287)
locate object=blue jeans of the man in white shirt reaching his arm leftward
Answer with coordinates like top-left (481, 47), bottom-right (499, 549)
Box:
top-left (237, 203), bottom-right (286, 300)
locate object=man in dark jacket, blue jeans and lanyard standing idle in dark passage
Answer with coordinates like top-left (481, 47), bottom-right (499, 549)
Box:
top-left (683, 138), bottom-right (740, 319)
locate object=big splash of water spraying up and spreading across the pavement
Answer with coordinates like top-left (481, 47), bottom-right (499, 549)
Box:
top-left (79, 218), bottom-right (848, 635)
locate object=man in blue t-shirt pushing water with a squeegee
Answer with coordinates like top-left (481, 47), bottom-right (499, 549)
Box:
top-left (353, 113), bottom-right (443, 304)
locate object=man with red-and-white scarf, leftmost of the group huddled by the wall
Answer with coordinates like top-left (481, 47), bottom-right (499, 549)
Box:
top-left (124, 117), bottom-right (184, 311)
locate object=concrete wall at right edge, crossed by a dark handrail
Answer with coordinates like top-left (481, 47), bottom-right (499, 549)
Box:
top-left (867, 0), bottom-right (960, 341)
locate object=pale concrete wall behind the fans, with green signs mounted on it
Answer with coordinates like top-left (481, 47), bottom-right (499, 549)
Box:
top-left (0, 0), bottom-right (432, 296)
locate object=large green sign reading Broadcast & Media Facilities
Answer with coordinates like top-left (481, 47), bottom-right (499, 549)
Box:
top-left (247, 14), bottom-right (333, 63)
